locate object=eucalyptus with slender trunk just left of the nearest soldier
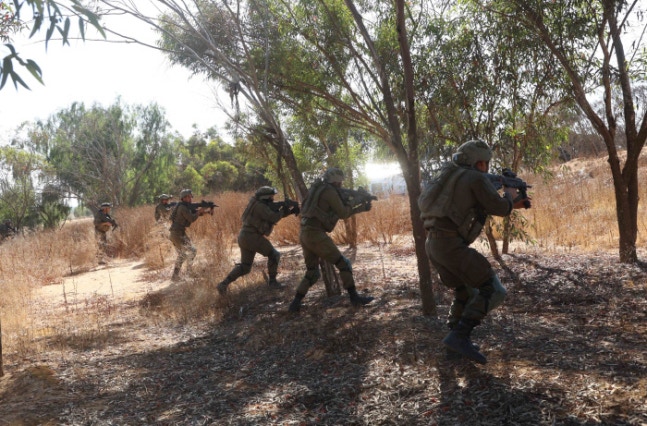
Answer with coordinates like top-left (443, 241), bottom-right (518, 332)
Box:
top-left (272, 0), bottom-right (436, 314)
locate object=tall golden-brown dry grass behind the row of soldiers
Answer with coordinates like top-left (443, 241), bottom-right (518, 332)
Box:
top-left (0, 159), bottom-right (647, 359)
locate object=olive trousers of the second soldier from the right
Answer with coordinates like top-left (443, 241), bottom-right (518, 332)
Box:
top-left (297, 227), bottom-right (355, 295)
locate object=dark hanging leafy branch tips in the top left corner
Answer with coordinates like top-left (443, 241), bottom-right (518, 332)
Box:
top-left (0, 0), bottom-right (105, 90)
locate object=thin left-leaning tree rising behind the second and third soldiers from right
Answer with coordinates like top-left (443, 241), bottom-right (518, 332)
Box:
top-left (101, 0), bottom-right (307, 199)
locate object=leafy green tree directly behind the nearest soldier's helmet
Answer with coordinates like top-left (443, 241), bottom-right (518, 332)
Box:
top-left (417, 3), bottom-right (572, 257)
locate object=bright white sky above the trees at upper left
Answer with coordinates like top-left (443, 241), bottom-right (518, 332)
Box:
top-left (0, 8), bottom-right (225, 144)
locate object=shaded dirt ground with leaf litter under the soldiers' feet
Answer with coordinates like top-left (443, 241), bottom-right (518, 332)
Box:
top-left (0, 245), bottom-right (647, 425)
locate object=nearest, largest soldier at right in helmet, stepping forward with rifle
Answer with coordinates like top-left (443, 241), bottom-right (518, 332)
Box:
top-left (418, 140), bottom-right (529, 364)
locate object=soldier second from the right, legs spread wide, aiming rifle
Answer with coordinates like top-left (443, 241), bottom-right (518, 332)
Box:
top-left (289, 167), bottom-right (373, 312)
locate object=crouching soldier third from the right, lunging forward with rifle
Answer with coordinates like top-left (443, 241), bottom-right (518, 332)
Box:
top-left (218, 186), bottom-right (299, 294)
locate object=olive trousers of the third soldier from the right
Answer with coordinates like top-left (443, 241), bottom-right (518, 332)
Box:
top-left (227, 231), bottom-right (281, 282)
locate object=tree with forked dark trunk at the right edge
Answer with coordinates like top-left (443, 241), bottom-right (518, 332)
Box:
top-left (473, 0), bottom-right (647, 263)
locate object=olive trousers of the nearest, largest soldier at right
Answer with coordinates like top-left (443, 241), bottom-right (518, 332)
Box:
top-left (425, 237), bottom-right (506, 327)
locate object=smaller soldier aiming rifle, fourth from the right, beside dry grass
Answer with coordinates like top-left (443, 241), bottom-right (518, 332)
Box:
top-left (170, 189), bottom-right (207, 281)
